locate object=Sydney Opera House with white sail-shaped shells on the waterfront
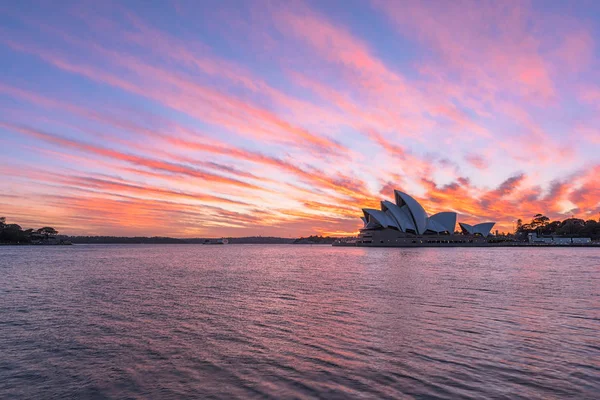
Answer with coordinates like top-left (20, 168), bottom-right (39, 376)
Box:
top-left (356, 190), bottom-right (495, 247)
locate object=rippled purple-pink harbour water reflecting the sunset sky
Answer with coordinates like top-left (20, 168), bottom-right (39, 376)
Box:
top-left (0, 245), bottom-right (600, 399)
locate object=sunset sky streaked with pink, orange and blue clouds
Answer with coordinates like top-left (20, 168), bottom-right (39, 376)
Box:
top-left (0, 0), bottom-right (600, 237)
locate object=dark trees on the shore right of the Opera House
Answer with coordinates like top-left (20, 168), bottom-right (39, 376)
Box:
top-left (515, 214), bottom-right (600, 240)
